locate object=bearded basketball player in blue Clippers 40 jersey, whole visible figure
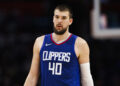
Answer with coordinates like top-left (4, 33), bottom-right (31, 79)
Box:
top-left (24, 5), bottom-right (94, 86)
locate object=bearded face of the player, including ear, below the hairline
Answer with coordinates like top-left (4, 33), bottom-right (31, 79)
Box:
top-left (53, 9), bottom-right (73, 35)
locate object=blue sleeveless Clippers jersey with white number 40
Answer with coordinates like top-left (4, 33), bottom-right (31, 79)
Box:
top-left (40, 34), bottom-right (80, 86)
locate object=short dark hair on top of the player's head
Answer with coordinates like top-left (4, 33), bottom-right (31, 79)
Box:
top-left (55, 4), bottom-right (73, 18)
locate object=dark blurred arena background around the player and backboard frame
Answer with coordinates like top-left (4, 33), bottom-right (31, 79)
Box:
top-left (0, 0), bottom-right (120, 86)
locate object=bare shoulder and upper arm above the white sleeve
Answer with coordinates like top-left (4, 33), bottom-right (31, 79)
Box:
top-left (75, 37), bottom-right (90, 64)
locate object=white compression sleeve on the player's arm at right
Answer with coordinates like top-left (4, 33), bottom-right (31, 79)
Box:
top-left (80, 63), bottom-right (94, 86)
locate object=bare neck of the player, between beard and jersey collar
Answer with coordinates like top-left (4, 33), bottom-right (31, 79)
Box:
top-left (53, 31), bottom-right (70, 43)
